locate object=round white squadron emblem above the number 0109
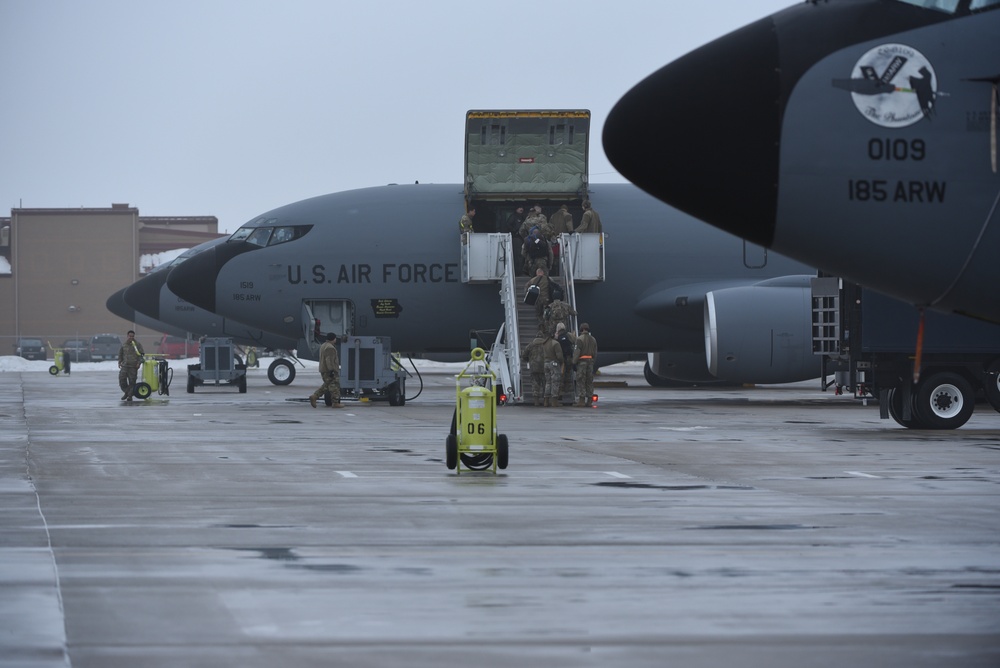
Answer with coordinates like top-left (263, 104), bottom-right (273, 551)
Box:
top-left (833, 44), bottom-right (938, 128)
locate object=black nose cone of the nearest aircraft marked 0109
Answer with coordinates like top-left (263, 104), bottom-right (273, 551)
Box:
top-left (603, 18), bottom-right (781, 245)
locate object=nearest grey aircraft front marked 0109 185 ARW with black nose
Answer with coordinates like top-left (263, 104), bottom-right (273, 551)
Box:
top-left (603, 0), bottom-right (1000, 322)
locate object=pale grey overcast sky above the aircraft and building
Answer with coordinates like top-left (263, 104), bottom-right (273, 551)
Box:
top-left (0, 0), bottom-right (796, 232)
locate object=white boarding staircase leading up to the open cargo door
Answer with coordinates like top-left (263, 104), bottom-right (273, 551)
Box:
top-left (462, 233), bottom-right (604, 403)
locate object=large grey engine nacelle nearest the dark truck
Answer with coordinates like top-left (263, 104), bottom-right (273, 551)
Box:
top-left (705, 276), bottom-right (821, 383)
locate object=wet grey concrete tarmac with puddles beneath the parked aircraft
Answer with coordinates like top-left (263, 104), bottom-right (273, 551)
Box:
top-left (0, 365), bottom-right (1000, 668)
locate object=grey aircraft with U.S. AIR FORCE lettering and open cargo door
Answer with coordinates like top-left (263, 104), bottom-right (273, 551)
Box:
top-left (156, 184), bottom-right (819, 392)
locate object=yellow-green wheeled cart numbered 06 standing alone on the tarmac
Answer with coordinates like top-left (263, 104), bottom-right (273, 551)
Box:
top-left (445, 348), bottom-right (508, 474)
